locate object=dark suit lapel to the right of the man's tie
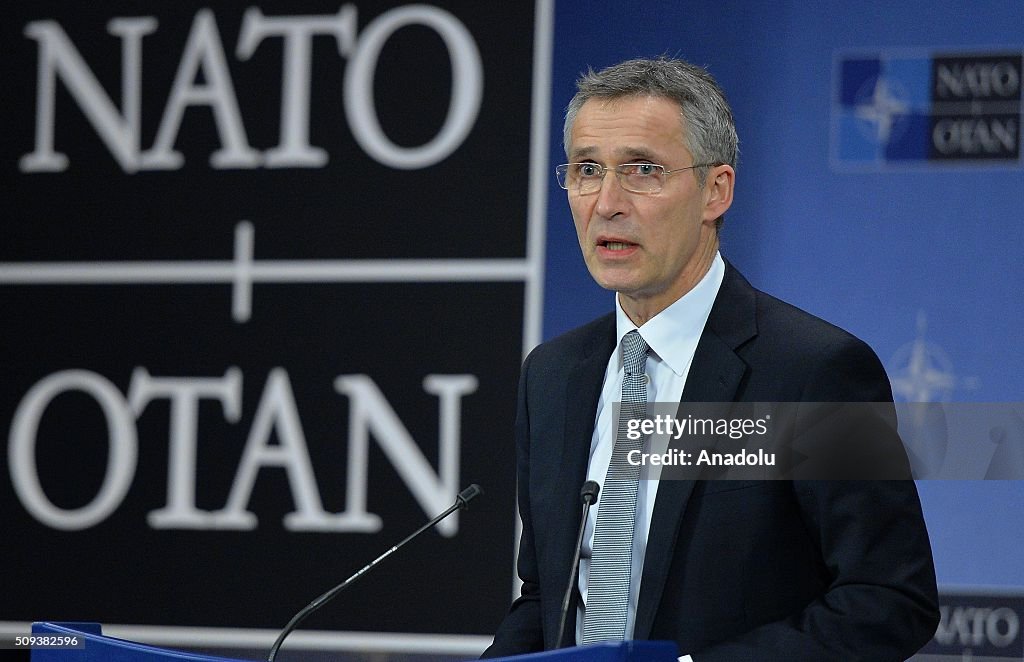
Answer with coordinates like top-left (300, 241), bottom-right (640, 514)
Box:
top-left (633, 262), bottom-right (757, 639)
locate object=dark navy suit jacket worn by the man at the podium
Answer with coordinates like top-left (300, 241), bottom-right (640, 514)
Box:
top-left (484, 265), bottom-right (938, 662)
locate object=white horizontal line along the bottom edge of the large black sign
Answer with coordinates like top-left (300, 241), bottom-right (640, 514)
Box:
top-left (0, 621), bottom-right (492, 657)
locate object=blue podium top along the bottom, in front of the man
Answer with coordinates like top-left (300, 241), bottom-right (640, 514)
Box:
top-left (32, 622), bottom-right (677, 662)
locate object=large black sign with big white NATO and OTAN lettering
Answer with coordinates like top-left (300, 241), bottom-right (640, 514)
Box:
top-left (0, 2), bottom-right (534, 633)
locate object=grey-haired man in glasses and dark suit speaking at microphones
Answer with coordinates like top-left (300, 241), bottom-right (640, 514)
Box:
top-left (484, 58), bottom-right (938, 662)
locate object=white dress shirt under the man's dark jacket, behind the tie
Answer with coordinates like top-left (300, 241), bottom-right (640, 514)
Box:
top-left (577, 254), bottom-right (725, 660)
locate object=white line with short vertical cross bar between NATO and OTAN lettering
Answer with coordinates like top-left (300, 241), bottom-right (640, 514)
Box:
top-left (0, 221), bottom-right (535, 322)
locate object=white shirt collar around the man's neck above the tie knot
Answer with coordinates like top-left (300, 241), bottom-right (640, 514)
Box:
top-left (615, 252), bottom-right (725, 376)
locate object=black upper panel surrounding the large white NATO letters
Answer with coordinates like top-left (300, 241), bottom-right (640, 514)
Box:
top-left (0, 1), bottom-right (532, 260)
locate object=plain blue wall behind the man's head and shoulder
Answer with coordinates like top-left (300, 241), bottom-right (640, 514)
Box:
top-left (545, 0), bottom-right (1024, 586)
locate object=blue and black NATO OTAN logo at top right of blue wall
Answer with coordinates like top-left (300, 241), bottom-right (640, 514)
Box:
top-left (831, 51), bottom-right (1022, 168)
